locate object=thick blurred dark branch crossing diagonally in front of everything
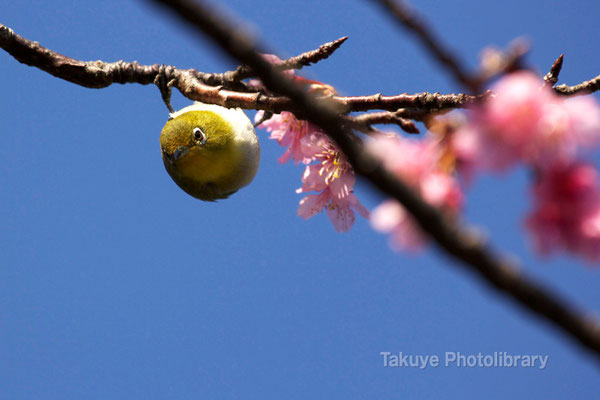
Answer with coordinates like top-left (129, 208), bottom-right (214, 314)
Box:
top-left (152, 0), bottom-right (600, 357)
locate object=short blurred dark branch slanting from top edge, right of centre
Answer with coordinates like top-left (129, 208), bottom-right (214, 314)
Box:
top-left (371, 0), bottom-right (480, 93)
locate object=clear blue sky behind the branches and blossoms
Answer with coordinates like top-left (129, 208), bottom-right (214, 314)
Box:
top-left (0, 0), bottom-right (600, 400)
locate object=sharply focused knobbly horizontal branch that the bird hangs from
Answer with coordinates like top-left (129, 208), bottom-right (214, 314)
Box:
top-left (0, 25), bottom-right (489, 115)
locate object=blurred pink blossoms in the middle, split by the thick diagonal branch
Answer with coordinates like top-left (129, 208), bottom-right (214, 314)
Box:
top-left (367, 135), bottom-right (463, 251)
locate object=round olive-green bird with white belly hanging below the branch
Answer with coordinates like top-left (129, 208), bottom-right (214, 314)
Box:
top-left (160, 102), bottom-right (260, 201)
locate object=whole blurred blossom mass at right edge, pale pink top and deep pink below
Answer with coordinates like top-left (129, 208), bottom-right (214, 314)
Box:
top-left (452, 72), bottom-right (600, 261)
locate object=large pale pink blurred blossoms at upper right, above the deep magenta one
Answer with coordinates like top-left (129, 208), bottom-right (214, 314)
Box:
top-left (452, 71), bottom-right (600, 175)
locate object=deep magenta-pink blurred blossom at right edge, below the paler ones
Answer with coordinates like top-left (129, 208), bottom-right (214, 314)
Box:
top-left (525, 163), bottom-right (600, 262)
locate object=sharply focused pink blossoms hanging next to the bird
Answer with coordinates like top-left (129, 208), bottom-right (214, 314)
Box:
top-left (256, 111), bottom-right (369, 232)
